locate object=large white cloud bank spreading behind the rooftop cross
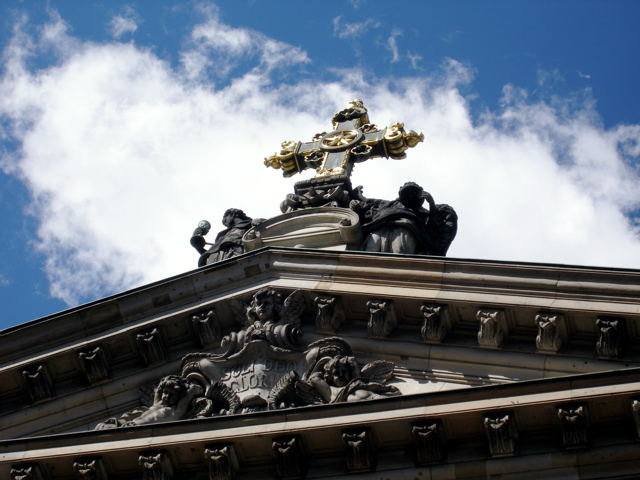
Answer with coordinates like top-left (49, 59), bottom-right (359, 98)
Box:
top-left (0, 12), bottom-right (640, 304)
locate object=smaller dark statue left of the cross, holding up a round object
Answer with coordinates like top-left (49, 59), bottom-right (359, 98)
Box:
top-left (191, 208), bottom-right (262, 267)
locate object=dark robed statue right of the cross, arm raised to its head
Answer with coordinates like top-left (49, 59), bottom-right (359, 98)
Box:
top-left (349, 182), bottom-right (458, 256)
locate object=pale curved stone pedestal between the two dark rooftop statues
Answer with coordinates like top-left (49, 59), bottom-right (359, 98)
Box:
top-left (242, 207), bottom-right (362, 252)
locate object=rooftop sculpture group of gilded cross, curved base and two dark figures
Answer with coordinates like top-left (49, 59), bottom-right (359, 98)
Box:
top-left (191, 100), bottom-right (458, 266)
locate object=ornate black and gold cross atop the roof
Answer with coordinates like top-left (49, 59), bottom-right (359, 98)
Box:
top-left (264, 100), bottom-right (424, 178)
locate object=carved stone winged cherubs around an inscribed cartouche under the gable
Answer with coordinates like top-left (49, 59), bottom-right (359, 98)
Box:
top-left (96, 288), bottom-right (400, 429)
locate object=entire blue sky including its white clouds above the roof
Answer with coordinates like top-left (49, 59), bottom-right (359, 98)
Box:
top-left (0, 0), bottom-right (640, 328)
